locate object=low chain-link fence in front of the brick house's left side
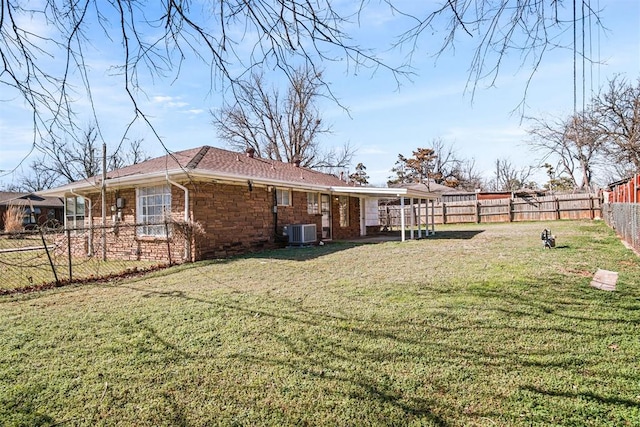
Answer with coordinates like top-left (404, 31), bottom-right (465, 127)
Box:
top-left (0, 223), bottom-right (186, 295)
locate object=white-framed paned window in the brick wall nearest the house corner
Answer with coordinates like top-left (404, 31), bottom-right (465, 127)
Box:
top-left (137, 185), bottom-right (171, 237)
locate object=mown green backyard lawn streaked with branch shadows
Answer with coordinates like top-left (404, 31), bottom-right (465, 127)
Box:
top-left (0, 222), bottom-right (640, 426)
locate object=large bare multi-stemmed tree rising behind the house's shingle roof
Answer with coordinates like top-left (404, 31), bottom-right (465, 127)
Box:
top-left (211, 67), bottom-right (353, 168)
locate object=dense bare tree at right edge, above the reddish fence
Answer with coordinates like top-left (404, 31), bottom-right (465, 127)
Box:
top-left (592, 76), bottom-right (640, 170)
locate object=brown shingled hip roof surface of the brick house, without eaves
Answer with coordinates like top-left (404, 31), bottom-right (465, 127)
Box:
top-left (107, 146), bottom-right (347, 186)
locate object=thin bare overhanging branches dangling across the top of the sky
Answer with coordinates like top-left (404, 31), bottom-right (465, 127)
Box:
top-left (0, 0), bottom-right (599, 169)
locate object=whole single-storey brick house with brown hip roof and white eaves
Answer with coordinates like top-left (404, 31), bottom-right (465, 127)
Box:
top-left (40, 146), bottom-right (436, 262)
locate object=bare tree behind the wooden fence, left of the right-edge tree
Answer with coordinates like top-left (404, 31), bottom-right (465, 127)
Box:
top-left (528, 113), bottom-right (604, 189)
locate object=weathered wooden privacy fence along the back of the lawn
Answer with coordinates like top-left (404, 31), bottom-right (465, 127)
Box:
top-left (379, 194), bottom-right (601, 229)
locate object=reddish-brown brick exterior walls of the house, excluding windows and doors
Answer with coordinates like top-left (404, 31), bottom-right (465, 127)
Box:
top-left (73, 182), bottom-right (360, 263)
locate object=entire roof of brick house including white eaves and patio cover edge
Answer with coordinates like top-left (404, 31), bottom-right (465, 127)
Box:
top-left (39, 146), bottom-right (442, 201)
